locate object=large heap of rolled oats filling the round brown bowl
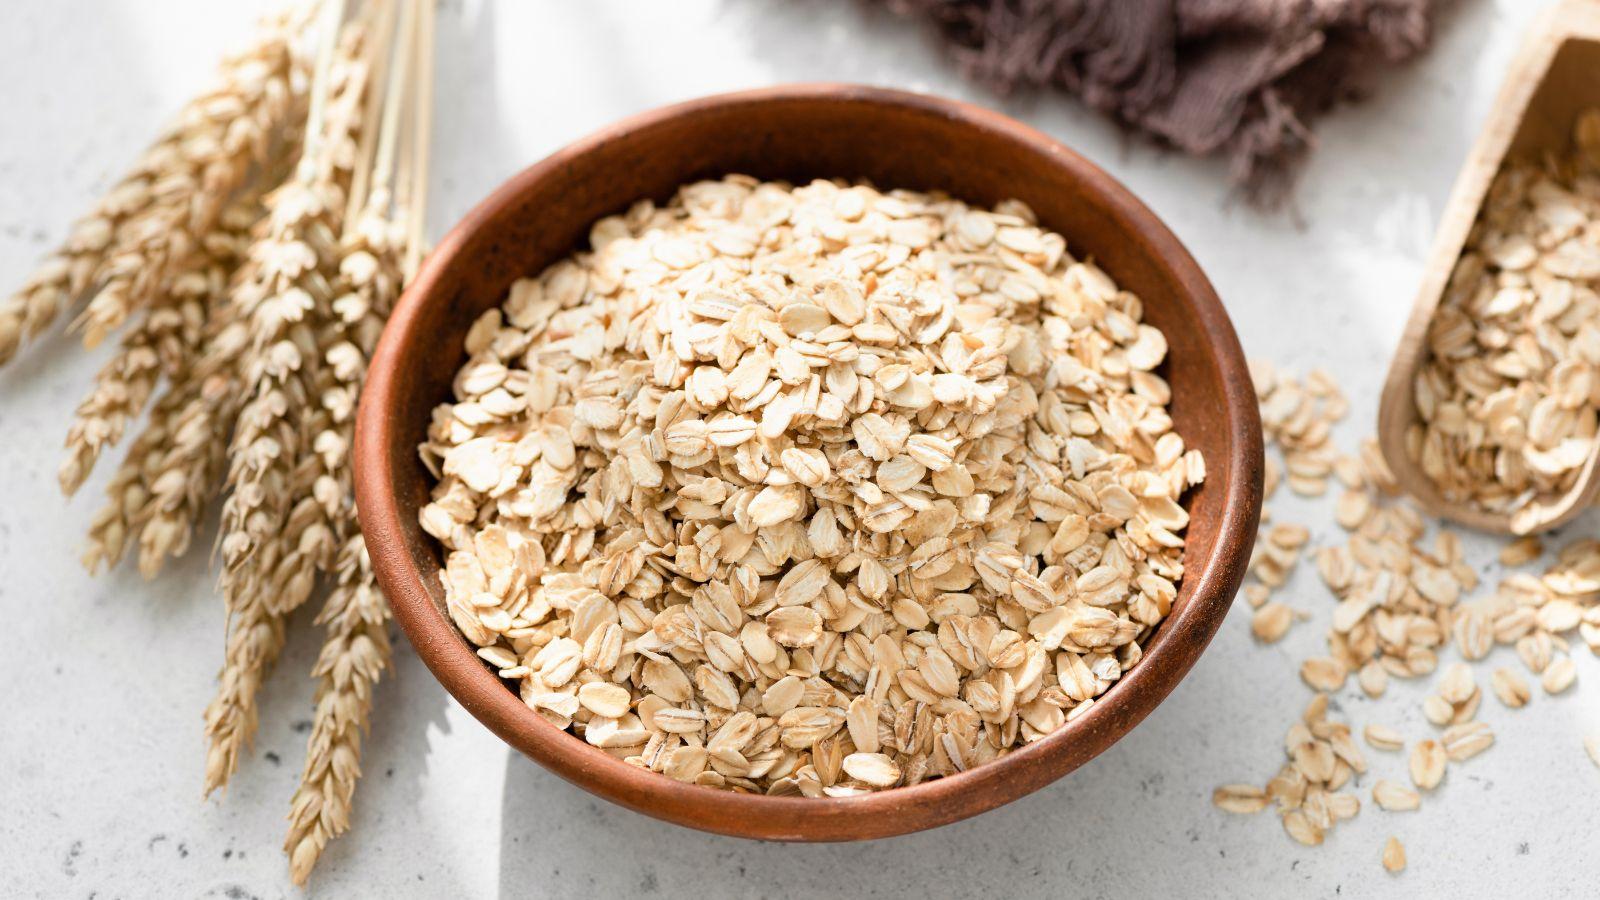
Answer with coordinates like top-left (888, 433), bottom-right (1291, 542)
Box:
top-left (421, 176), bottom-right (1203, 798)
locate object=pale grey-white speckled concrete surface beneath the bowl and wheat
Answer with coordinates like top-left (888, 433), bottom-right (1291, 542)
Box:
top-left (0, 0), bottom-right (1600, 898)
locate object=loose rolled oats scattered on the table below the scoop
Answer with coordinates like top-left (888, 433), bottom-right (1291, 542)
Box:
top-left (1213, 362), bottom-right (1600, 871)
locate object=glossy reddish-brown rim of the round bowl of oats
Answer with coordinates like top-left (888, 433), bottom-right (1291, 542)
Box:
top-left (354, 83), bottom-right (1262, 841)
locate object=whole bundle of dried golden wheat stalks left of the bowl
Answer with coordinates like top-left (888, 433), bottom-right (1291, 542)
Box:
top-left (0, 0), bottom-right (434, 884)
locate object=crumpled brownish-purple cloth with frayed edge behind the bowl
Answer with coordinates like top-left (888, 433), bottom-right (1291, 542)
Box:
top-left (867, 0), bottom-right (1445, 205)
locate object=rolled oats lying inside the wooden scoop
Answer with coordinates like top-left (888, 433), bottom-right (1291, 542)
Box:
top-left (1406, 110), bottom-right (1600, 532)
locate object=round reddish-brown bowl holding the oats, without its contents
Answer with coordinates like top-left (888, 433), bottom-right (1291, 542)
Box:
top-left (355, 85), bottom-right (1262, 841)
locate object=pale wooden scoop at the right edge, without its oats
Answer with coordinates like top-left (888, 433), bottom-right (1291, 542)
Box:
top-left (1378, 0), bottom-right (1600, 535)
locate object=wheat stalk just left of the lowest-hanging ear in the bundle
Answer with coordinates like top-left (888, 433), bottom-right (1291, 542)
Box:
top-left (205, 5), bottom-right (370, 793)
